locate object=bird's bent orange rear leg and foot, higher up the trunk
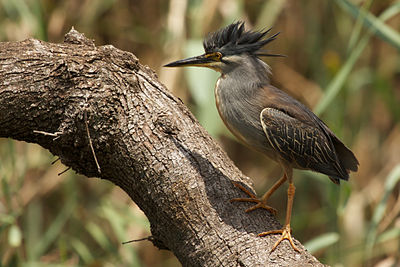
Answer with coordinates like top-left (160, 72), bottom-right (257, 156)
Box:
top-left (231, 173), bottom-right (287, 215)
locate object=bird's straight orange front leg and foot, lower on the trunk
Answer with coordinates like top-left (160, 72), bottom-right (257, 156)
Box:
top-left (258, 182), bottom-right (300, 252)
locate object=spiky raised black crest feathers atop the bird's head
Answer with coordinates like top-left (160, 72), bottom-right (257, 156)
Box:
top-left (203, 21), bottom-right (282, 56)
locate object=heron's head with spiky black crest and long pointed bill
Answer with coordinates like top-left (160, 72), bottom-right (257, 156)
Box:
top-left (165, 21), bottom-right (282, 73)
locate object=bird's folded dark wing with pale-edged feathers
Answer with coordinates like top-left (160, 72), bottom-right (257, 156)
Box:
top-left (260, 108), bottom-right (348, 183)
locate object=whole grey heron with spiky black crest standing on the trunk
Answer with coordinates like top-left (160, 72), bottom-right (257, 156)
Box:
top-left (164, 21), bottom-right (359, 252)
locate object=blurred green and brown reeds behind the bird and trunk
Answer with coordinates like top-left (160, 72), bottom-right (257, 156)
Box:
top-left (0, 0), bottom-right (400, 267)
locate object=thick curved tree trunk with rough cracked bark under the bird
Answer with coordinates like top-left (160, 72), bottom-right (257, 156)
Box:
top-left (0, 29), bottom-right (323, 266)
